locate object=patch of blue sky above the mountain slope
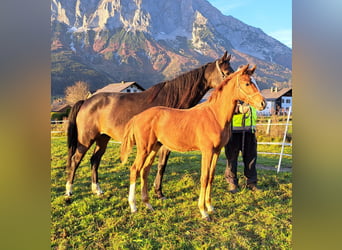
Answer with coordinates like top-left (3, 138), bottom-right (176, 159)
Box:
top-left (208, 0), bottom-right (292, 48)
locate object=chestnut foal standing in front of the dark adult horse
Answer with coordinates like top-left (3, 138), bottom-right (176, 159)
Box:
top-left (121, 64), bottom-right (266, 220)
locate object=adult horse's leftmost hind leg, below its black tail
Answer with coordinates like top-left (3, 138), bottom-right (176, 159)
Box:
top-left (65, 143), bottom-right (92, 196)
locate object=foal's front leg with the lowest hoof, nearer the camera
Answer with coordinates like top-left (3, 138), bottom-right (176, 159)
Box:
top-left (198, 152), bottom-right (213, 221)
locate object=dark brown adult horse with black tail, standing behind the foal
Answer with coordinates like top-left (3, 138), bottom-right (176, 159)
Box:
top-left (65, 51), bottom-right (234, 196)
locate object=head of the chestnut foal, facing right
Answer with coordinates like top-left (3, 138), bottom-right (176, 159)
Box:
top-left (234, 64), bottom-right (266, 111)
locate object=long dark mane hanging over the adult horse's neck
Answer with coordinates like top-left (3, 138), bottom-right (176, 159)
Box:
top-left (148, 64), bottom-right (208, 108)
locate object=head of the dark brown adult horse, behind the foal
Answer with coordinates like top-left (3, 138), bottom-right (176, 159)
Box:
top-left (205, 51), bottom-right (234, 88)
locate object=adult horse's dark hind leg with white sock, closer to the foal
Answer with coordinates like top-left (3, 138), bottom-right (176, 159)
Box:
top-left (90, 134), bottom-right (110, 195)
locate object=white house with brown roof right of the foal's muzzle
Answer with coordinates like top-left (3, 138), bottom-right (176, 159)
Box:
top-left (258, 87), bottom-right (292, 116)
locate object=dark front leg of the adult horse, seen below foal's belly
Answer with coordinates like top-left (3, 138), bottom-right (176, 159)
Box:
top-left (154, 147), bottom-right (171, 199)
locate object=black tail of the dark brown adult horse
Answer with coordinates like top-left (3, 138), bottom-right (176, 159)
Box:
top-left (67, 100), bottom-right (84, 166)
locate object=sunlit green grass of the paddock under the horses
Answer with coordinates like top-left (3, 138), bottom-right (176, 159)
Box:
top-left (51, 137), bottom-right (292, 249)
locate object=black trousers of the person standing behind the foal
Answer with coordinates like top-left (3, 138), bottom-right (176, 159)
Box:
top-left (224, 132), bottom-right (258, 186)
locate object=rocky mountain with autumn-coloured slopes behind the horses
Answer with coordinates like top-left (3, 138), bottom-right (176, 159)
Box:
top-left (51, 0), bottom-right (292, 95)
